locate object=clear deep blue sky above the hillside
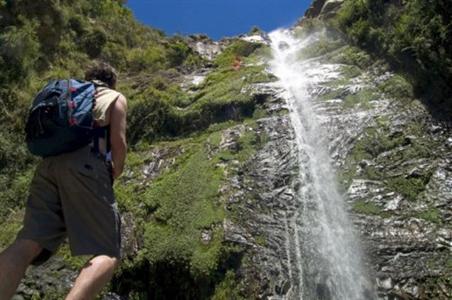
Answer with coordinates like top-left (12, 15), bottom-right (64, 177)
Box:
top-left (127, 0), bottom-right (312, 39)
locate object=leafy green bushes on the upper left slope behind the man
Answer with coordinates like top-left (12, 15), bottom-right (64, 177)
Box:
top-left (0, 0), bottom-right (201, 220)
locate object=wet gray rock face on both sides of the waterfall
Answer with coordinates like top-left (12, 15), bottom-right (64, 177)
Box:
top-left (231, 29), bottom-right (452, 299)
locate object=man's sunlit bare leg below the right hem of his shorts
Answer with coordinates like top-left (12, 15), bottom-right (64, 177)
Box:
top-left (66, 255), bottom-right (119, 300)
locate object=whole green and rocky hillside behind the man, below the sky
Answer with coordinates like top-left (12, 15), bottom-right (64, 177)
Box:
top-left (0, 0), bottom-right (452, 300)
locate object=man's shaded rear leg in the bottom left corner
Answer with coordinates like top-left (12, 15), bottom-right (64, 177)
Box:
top-left (0, 240), bottom-right (42, 300)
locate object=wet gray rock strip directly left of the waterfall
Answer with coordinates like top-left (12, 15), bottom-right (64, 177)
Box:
top-left (224, 116), bottom-right (297, 299)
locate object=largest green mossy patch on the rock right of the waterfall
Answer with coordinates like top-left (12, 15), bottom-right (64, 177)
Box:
top-left (340, 117), bottom-right (438, 201)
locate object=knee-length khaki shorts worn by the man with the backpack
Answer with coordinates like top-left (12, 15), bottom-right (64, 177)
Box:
top-left (17, 147), bottom-right (121, 264)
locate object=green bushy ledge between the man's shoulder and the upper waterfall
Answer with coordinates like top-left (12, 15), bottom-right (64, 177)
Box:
top-left (129, 41), bottom-right (273, 144)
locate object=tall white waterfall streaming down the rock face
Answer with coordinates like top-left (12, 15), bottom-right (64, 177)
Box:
top-left (270, 30), bottom-right (375, 300)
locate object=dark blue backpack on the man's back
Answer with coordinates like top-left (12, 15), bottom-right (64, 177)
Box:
top-left (25, 79), bottom-right (105, 157)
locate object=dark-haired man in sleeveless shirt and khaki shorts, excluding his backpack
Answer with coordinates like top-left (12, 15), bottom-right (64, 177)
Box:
top-left (0, 63), bottom-right (127, 300)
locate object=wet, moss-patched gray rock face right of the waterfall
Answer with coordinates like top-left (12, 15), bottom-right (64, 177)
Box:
top-left (280, 29), bottom-right (452, 299)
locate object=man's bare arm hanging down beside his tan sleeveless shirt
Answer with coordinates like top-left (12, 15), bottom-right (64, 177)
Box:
top-left (110, 95), bottom-right (127, 178)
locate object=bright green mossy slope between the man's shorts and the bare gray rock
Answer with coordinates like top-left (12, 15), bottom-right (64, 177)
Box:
top-left (111, 124), bottom-right (259, 299)
